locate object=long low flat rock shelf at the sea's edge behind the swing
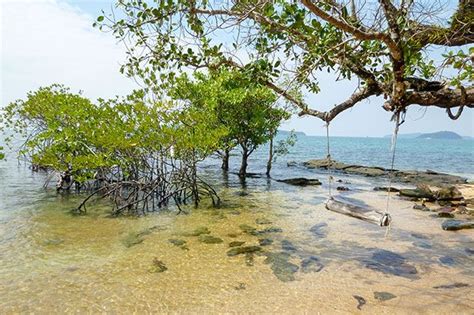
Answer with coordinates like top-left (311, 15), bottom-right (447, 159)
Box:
top-left (303, 159), bottom-right (467, 186)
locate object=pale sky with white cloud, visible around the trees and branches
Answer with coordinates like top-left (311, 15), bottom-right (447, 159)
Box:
top-left (0, 0), bottom-right (474, 137)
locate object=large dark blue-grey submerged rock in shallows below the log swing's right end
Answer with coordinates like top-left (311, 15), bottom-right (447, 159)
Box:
top-left (365, 249), bottom-right (418, 279)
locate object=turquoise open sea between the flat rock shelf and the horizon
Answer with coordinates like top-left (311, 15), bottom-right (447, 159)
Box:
top-left (234, 136), bottom-right (474, 180)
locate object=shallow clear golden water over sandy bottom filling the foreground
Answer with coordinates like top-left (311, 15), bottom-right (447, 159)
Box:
top-left (0, 138), bottom-right (474, 314)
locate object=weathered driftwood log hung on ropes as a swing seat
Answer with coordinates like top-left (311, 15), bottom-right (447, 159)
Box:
top-left (326, 197), bottom-right (392, 226)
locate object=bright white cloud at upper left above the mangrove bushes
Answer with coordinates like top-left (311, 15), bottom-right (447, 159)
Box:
top-left (0, 0), bottom-right (137, 107)
